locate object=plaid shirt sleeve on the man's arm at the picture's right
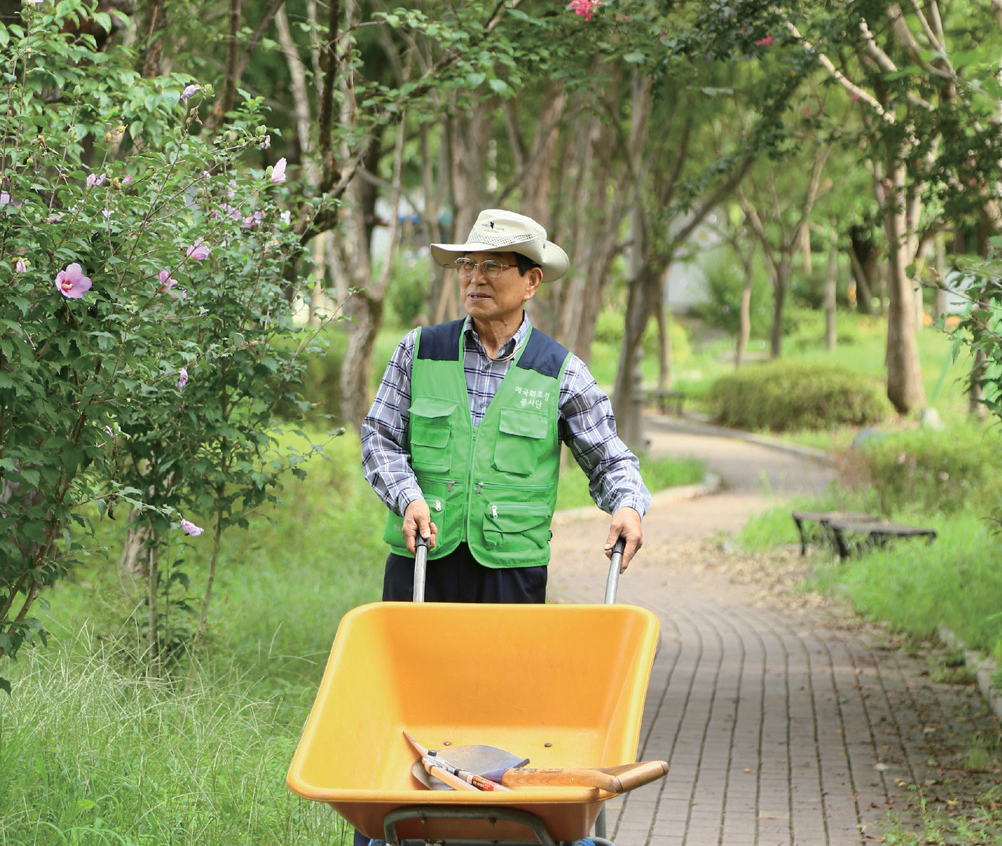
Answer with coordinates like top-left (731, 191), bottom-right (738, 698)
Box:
top-left (560, 356), bottom-right (650, 517)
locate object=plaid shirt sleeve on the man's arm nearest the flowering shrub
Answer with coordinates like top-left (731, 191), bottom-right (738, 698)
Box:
top-left (362, 331), bottom-right (422, 515)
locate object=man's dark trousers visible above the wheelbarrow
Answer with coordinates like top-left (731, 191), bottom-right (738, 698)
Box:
top-left (383, 543), bottom-right (546, 604)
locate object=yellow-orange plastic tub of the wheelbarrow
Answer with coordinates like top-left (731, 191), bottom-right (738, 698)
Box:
top-left (287, 602), bottom-right (658, 840)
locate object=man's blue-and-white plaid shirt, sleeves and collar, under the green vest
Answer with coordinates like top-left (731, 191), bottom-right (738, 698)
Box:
top-left (362, 316), bottom-right (650, 517)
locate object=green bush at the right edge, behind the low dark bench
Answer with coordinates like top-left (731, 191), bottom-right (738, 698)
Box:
top-left (858, 426), bottom-right (1002, 514)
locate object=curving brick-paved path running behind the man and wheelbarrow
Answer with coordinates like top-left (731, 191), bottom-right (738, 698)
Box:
top-left (549, 418), bottom-right (997, 846)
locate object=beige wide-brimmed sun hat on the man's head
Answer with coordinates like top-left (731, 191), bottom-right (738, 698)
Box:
top-left (431, 208), bottom-right (570, 282)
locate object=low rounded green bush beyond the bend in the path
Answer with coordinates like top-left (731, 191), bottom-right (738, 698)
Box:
top-left (705, 361), bottom-right (891, 432)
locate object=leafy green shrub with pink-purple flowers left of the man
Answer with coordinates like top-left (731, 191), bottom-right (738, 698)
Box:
top-left (0, 0), bottom-right (336, 687)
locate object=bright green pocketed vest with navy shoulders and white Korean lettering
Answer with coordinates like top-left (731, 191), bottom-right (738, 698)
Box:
top-left (385, 320), bottom-right (570, 567)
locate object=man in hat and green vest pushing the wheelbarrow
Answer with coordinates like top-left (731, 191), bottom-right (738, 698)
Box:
top-left (362, 209), bottom-right (650, 602)
